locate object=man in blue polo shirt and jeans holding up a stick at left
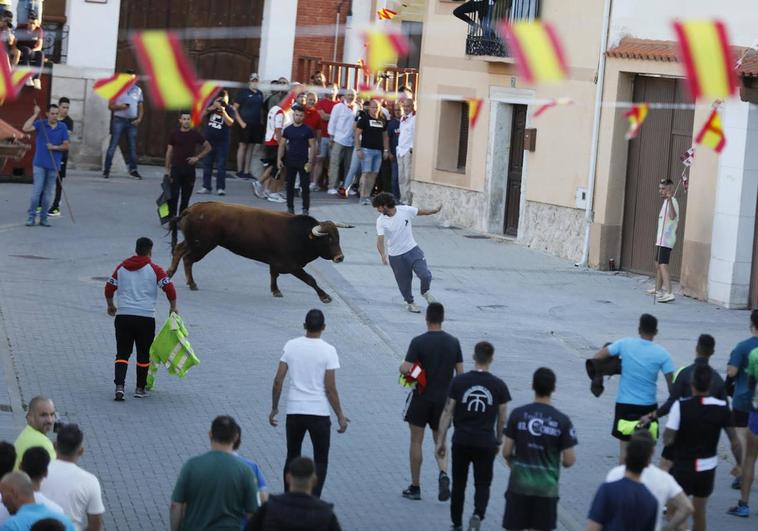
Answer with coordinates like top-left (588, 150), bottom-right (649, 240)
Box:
top-left (22, 104), bottom-right (68, 227)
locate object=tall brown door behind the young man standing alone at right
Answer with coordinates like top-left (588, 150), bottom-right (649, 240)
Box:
top-left (621, 76), bottom-right (695, 278)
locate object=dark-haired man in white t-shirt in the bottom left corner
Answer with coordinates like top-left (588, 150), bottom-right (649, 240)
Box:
top-left (42, 424), bottom-right (105, 531)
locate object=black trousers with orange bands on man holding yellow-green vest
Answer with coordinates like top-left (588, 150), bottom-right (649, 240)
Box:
top-left (113, 315), bottom-right (155, 388)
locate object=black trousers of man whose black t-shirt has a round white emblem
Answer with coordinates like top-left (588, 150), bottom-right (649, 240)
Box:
top-left (450, 444), bottom-right (497, 526)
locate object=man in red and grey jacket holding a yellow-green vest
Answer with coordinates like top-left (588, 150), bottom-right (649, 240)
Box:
top-left (105, 238), bottom-right (176, 402)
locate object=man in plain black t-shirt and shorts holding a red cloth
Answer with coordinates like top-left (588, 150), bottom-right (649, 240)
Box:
top-left (400, 302), bottom-right (463, 501)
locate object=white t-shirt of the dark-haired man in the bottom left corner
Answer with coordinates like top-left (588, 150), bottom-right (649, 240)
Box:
top-left (40, 459), bottom-right (105, 531)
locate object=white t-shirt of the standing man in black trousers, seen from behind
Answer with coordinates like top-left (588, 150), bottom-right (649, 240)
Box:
top-left (281, 336), bottom-right (340, 417)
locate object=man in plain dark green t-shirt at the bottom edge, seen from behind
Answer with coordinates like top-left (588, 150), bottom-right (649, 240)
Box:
top-left (170, 415), bottom-right (258, 531)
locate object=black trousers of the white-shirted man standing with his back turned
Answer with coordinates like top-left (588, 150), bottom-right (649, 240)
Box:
top-left (284, 416), bottom-right (332, 498)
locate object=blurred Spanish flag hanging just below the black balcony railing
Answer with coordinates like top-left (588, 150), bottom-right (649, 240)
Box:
top-left (499, 21), bottom-right (568, 83)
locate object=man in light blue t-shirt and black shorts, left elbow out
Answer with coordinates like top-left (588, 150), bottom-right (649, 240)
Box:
top-left (595, 313), bottom-right (675, 465)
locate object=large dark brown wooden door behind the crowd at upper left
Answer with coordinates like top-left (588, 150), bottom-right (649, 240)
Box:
top-left (116, 0), bottom-right (264, 164)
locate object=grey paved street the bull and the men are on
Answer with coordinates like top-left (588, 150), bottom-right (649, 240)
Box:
top-left (0, 169), bottom-right (758, 531)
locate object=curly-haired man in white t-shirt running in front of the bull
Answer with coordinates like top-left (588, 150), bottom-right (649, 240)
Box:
top-left (371, 192), bottom-right (442, 313)
